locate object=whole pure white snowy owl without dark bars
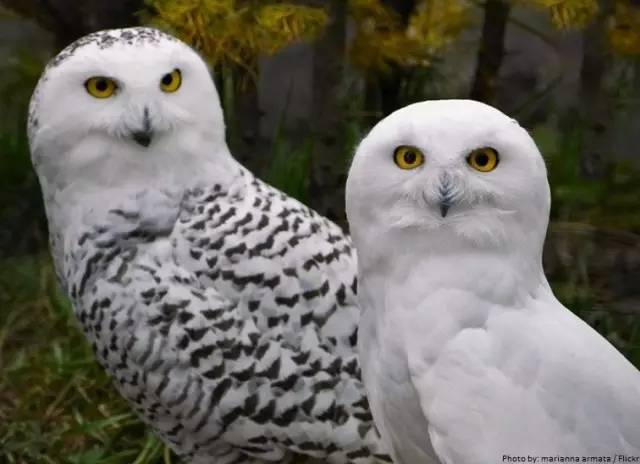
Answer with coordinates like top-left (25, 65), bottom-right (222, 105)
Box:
top-left (347, 100), bottom-right (640, 464)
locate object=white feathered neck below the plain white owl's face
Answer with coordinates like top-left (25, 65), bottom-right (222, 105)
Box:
top-left (356, 223), bottom-right (550, 311)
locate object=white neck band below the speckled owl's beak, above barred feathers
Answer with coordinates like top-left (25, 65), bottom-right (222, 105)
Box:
top-left (40, 134), bottom-right (242, 198)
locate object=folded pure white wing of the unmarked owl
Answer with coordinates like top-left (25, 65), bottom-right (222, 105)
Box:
top-left (409, 299), bottom-right (640, 464)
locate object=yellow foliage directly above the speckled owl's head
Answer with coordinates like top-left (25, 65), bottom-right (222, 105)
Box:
top-left (146, 0), bottom-right (327, 75)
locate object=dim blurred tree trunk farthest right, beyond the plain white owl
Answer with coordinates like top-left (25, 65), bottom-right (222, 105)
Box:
top-left (578, 6), bottom-right (614, 179)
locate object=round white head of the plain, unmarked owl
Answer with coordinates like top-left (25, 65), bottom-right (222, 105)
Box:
top-left (347, 100), bottom-right (550, 254)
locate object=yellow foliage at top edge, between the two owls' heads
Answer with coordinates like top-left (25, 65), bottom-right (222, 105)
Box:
top-left (349, 0), bottom-right (469, 74)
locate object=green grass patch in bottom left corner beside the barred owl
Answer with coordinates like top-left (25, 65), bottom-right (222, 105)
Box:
top-left (0, 255), bottom-right (177, 464)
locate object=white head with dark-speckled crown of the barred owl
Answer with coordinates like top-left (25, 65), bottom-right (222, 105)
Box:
top-left (29, 28), bottom-right (224, 188)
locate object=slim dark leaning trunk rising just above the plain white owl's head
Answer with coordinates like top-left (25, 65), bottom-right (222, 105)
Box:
top-left (470, 0), bottom-right (511, 104)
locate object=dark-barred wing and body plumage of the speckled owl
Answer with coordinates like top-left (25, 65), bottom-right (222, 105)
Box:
top-left (71, 172), bottom-right (389, 463)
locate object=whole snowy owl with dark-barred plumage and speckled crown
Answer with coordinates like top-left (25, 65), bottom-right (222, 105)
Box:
top-left (29, 28), bottom-right (390, 464)
